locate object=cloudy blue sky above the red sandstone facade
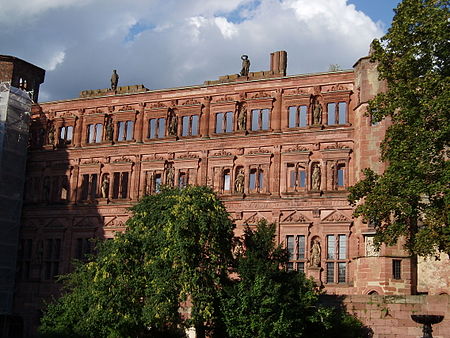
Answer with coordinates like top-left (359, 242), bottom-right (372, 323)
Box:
top-left (0, 0), bottom-right (397, 101)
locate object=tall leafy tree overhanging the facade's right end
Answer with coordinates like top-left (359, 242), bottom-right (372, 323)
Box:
top-left (349, 0), bottom-right (450, 255)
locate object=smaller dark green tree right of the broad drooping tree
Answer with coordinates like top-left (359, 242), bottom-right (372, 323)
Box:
top-left (222, 221), bottom-right (361, 338)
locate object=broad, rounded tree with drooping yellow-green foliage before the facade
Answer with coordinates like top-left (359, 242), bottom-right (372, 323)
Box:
top-left (40, 187), bottom-right (234, 337)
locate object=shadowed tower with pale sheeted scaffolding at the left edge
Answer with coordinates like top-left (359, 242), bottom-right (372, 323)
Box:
top-left (0, 55), bottom-right (45, 337)
